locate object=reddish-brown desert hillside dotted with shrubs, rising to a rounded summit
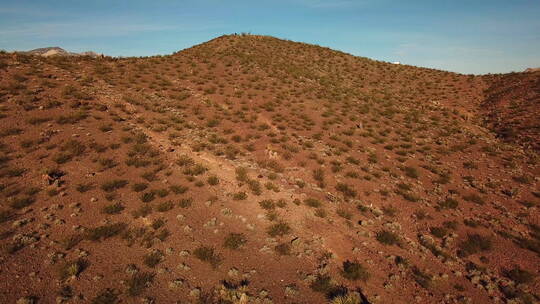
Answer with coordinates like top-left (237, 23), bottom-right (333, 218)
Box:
top-left (0, 35), bottom-right (540, 304)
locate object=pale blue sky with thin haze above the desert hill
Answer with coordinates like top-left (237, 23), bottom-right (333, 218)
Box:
top-left (0, 0), bottom-right (540, 74)
